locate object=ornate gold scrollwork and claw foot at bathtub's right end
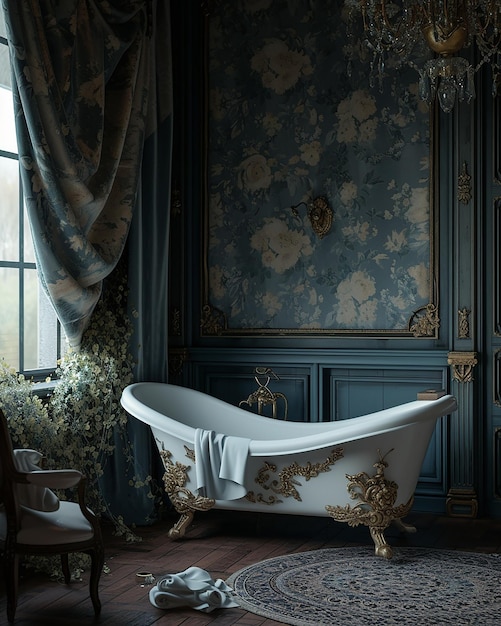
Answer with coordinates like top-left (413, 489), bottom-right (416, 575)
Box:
top-left (325, 450), bottom-right (414, 559)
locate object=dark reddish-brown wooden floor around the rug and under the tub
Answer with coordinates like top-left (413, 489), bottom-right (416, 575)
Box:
top-left (0, 511), bottom-right (501, 626)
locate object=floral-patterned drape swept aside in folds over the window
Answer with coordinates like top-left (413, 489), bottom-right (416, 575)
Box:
top-left (3, 0), bottom-right (154, 347)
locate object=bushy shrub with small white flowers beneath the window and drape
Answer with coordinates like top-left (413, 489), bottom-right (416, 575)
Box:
top-left (0, 266), bottom-right (151, 562)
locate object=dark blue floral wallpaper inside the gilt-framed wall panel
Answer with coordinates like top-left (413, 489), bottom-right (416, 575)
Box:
top-left (205, 0), bottom-right (432, 334)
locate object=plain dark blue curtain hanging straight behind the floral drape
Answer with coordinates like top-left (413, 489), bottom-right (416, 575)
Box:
top-left (97, 0), bottom-right (173, 525)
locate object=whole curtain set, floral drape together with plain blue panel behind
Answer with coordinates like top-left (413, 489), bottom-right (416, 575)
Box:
top-left (2, 0), bottom-right (172, 524)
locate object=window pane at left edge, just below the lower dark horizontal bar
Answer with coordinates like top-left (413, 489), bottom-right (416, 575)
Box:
top-left (0, 267), bottom-right (19, 369)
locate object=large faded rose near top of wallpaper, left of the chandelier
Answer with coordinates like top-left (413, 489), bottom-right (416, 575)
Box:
top-left (251, 39), bottom-right (313, 95)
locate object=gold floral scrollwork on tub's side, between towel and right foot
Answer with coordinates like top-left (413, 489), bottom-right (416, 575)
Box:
top-left (246, 448), bottom-right (344, 505)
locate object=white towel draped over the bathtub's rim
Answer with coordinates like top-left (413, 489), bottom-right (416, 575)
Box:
top-left (195, 428), bottom-right (250, 500)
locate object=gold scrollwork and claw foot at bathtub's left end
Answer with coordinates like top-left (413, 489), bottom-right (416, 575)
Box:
top-left (160, 450), bottom-right (216, 540)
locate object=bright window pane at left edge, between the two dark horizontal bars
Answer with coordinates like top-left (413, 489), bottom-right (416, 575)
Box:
top-left (0, 157), bottom-right (19, 261)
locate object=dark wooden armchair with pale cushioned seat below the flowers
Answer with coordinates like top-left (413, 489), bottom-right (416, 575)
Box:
top-left (0, 410), bottom-right (104, 623)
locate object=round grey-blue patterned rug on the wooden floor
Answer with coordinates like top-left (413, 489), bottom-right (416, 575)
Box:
top-left (226, 547), bottom-right (501, 626)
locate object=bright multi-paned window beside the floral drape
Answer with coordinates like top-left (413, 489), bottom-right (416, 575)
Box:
top-left (0, 10), bottom-right (62, 379)
